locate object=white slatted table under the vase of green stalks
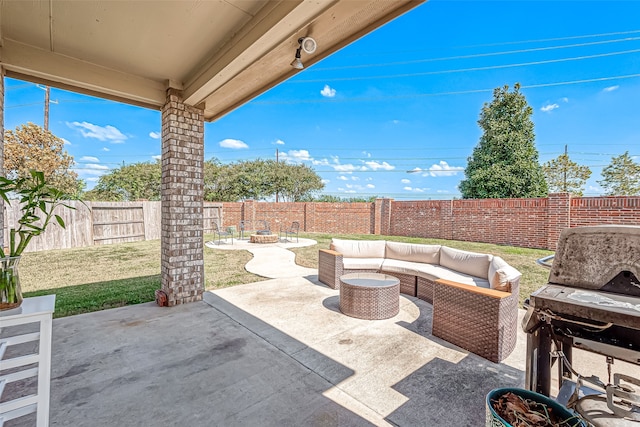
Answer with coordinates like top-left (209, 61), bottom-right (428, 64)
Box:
top-left (0, 295), bottom-right (56, 427)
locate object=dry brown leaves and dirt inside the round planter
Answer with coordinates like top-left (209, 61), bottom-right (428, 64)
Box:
top-left (491, 392), bottom-right (582, 427)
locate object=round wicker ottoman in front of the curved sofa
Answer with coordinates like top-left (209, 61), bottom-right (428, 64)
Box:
top-left (340, 273), bottom-right (400, 320)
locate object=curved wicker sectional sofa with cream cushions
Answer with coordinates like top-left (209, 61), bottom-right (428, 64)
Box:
top-left (318, 239), bottom-right (521, 362)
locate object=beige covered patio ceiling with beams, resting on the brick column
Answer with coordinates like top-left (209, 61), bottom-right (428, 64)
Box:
top-left (0, 0), bottom-right (424, 121)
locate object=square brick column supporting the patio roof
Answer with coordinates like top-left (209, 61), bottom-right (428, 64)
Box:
top-left (161, 89), bottom-right (204, 306)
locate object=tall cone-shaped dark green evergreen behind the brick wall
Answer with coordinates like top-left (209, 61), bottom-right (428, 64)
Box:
top-left (459, 83), bottom-right (547, 199)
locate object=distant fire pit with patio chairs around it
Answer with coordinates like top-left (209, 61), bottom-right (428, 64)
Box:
top-left (213, 219), bottom-right (300, 245)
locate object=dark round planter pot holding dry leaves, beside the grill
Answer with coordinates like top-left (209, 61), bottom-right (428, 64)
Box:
top-left (486, 388), bottom-right (587, 427)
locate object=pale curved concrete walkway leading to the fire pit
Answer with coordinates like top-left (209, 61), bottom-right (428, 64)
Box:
top-left (204, 239), bottom-right (318, 279)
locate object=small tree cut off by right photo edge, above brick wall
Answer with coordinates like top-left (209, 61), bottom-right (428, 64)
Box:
top-left (598, 151), bottom-right (640, 196)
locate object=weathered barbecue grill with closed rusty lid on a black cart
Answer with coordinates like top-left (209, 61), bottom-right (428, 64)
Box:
top-left (522, 226), bottom-right (640, 427)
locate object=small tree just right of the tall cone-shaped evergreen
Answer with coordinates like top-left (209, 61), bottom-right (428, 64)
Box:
top-left (542, 149), bottom-right (591, 197)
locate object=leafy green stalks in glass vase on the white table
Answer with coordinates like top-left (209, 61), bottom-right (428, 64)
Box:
top-left (0, 171), bottom-right (75, 310)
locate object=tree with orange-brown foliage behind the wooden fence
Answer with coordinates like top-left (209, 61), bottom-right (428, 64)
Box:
top-left (4, 123), bottom-right (84, 196)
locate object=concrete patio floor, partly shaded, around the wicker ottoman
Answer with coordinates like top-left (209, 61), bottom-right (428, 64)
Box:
top-left (5, 239), bottom-right (636, 426)
